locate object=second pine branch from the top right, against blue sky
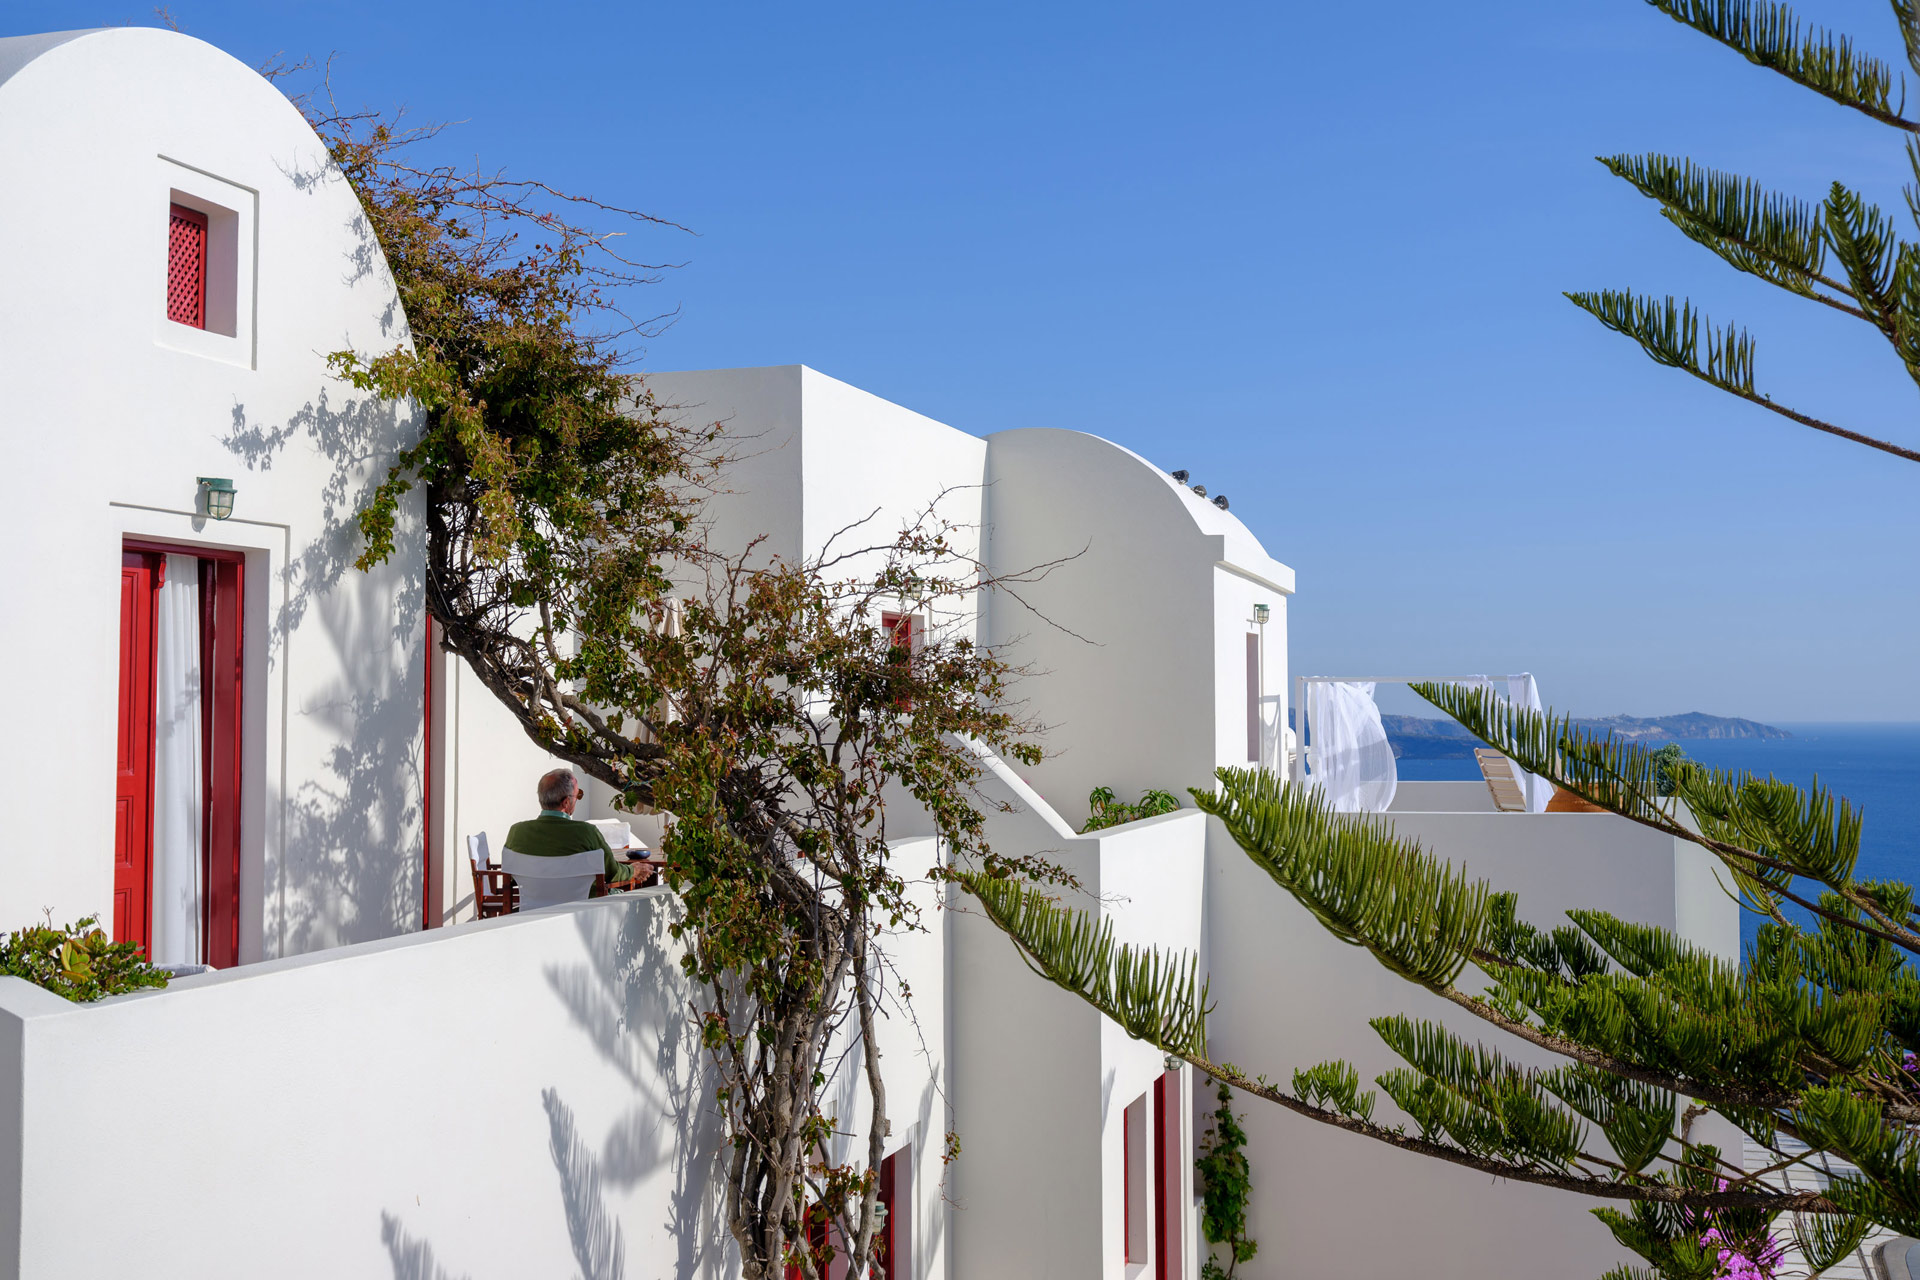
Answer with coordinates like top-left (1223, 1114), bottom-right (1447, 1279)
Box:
top-left (1597, 154), bottom-right (1868, 320)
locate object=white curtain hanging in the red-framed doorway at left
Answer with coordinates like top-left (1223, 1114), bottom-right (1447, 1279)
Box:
top-left (152, 555), bottom-right (202, 965)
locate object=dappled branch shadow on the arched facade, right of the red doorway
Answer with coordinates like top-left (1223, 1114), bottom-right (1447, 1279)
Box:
top-left (223, 385), bottom-right (426, 954)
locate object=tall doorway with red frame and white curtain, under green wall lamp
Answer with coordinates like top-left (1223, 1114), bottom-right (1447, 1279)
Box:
top-left (113, 541), bottom-right (246, 967)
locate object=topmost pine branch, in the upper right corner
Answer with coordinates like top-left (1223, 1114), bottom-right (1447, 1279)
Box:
top-left (1647, 0), bottom-right (1920, 132)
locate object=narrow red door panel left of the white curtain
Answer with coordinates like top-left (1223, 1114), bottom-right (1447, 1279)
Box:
top-left (113, 551), bottom-right (163, 950)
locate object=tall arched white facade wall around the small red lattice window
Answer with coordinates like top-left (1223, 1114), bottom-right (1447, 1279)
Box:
top-left (0, 27), bottom-right (424, 960)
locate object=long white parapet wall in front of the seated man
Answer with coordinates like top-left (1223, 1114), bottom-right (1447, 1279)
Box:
top-left (0, 882), bottom-right (948, 1280)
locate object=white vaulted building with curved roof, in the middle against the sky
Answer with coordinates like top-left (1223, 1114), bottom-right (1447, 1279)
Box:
top-left (987, 428), bottom-right (1294, 823)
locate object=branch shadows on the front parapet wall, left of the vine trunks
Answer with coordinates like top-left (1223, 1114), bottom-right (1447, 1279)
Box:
top-left (380, 892), bottom-right (739, 1280)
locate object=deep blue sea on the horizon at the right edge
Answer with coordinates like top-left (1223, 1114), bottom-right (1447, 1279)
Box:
top-left (1400, 723), bottom-right (1920, 940)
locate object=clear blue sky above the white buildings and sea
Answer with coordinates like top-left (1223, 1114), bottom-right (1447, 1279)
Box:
top-left (18, 0), bottom-right (1920, 720)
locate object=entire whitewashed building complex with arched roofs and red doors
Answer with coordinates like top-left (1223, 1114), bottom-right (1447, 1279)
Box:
top-left (0, 29), bottom-right (1736, 1280)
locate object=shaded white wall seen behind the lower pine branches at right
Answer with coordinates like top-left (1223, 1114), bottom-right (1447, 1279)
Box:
top-left (1208, 783), bottom-right (1740, 1280)
